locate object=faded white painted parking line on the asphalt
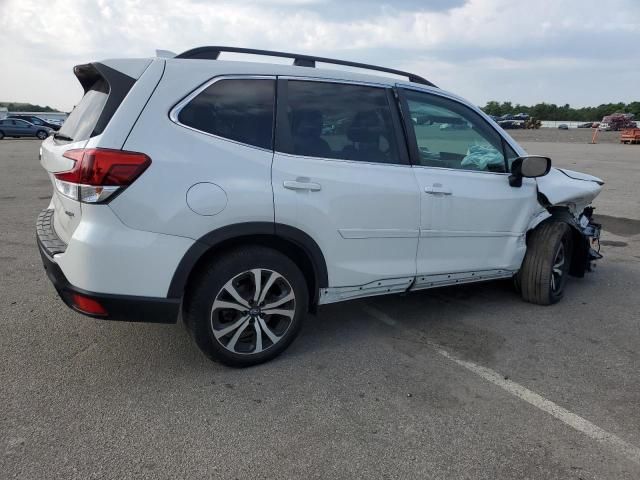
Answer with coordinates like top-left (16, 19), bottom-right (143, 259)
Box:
top-left (363, 305), bottom-right (640, 464)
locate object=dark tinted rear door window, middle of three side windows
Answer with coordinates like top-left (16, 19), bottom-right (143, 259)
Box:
top-left (284, 80), bottom-right (401, 163)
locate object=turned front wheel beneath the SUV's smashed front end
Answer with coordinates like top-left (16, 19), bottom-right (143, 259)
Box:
top-left (516, 222), bottom-right (573, 305)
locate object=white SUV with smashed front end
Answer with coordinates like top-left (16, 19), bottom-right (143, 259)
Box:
top-left (37, 47), bottom-right (603, 366)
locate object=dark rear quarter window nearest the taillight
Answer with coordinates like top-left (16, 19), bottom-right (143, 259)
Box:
top-left (178, 79), bottom-right (275, 149)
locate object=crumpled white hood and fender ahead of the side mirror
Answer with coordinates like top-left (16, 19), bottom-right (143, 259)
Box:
top-left (536, 168), bottom-right (604, 210)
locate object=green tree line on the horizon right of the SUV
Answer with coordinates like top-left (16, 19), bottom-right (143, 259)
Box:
top-left (481, 100), bottom-right (640, 122)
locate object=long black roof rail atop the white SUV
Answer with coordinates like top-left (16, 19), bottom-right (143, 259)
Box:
top-left (175, 46), bottom-right (435, 87)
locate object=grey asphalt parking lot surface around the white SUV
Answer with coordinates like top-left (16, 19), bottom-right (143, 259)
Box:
top-left (0, 131), bottom-right (640, 480)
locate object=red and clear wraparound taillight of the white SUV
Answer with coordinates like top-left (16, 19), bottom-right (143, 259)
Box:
top-left (53, 148), bottom-right (151, 203)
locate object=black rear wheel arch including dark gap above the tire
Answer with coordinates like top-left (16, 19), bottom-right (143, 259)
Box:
top-left (167, 222), bottom-right (329, 310)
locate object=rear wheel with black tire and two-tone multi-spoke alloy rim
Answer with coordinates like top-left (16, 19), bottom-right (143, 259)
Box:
top-left (185, 246), bottom-right (309, 367)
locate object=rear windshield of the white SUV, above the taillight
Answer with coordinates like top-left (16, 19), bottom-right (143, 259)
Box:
top-left (58, 78), bottom-right (109, 141)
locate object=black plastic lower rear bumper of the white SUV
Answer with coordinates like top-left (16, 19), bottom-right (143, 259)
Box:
top-left (36, 210), bottom-right (180, 323)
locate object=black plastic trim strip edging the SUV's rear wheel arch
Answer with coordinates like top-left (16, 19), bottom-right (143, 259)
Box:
top-left (167, 222), bottom-right (329, 304)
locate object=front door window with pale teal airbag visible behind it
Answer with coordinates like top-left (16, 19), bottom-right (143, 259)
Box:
top-left (405, 90), bottom-right (505, 172)
